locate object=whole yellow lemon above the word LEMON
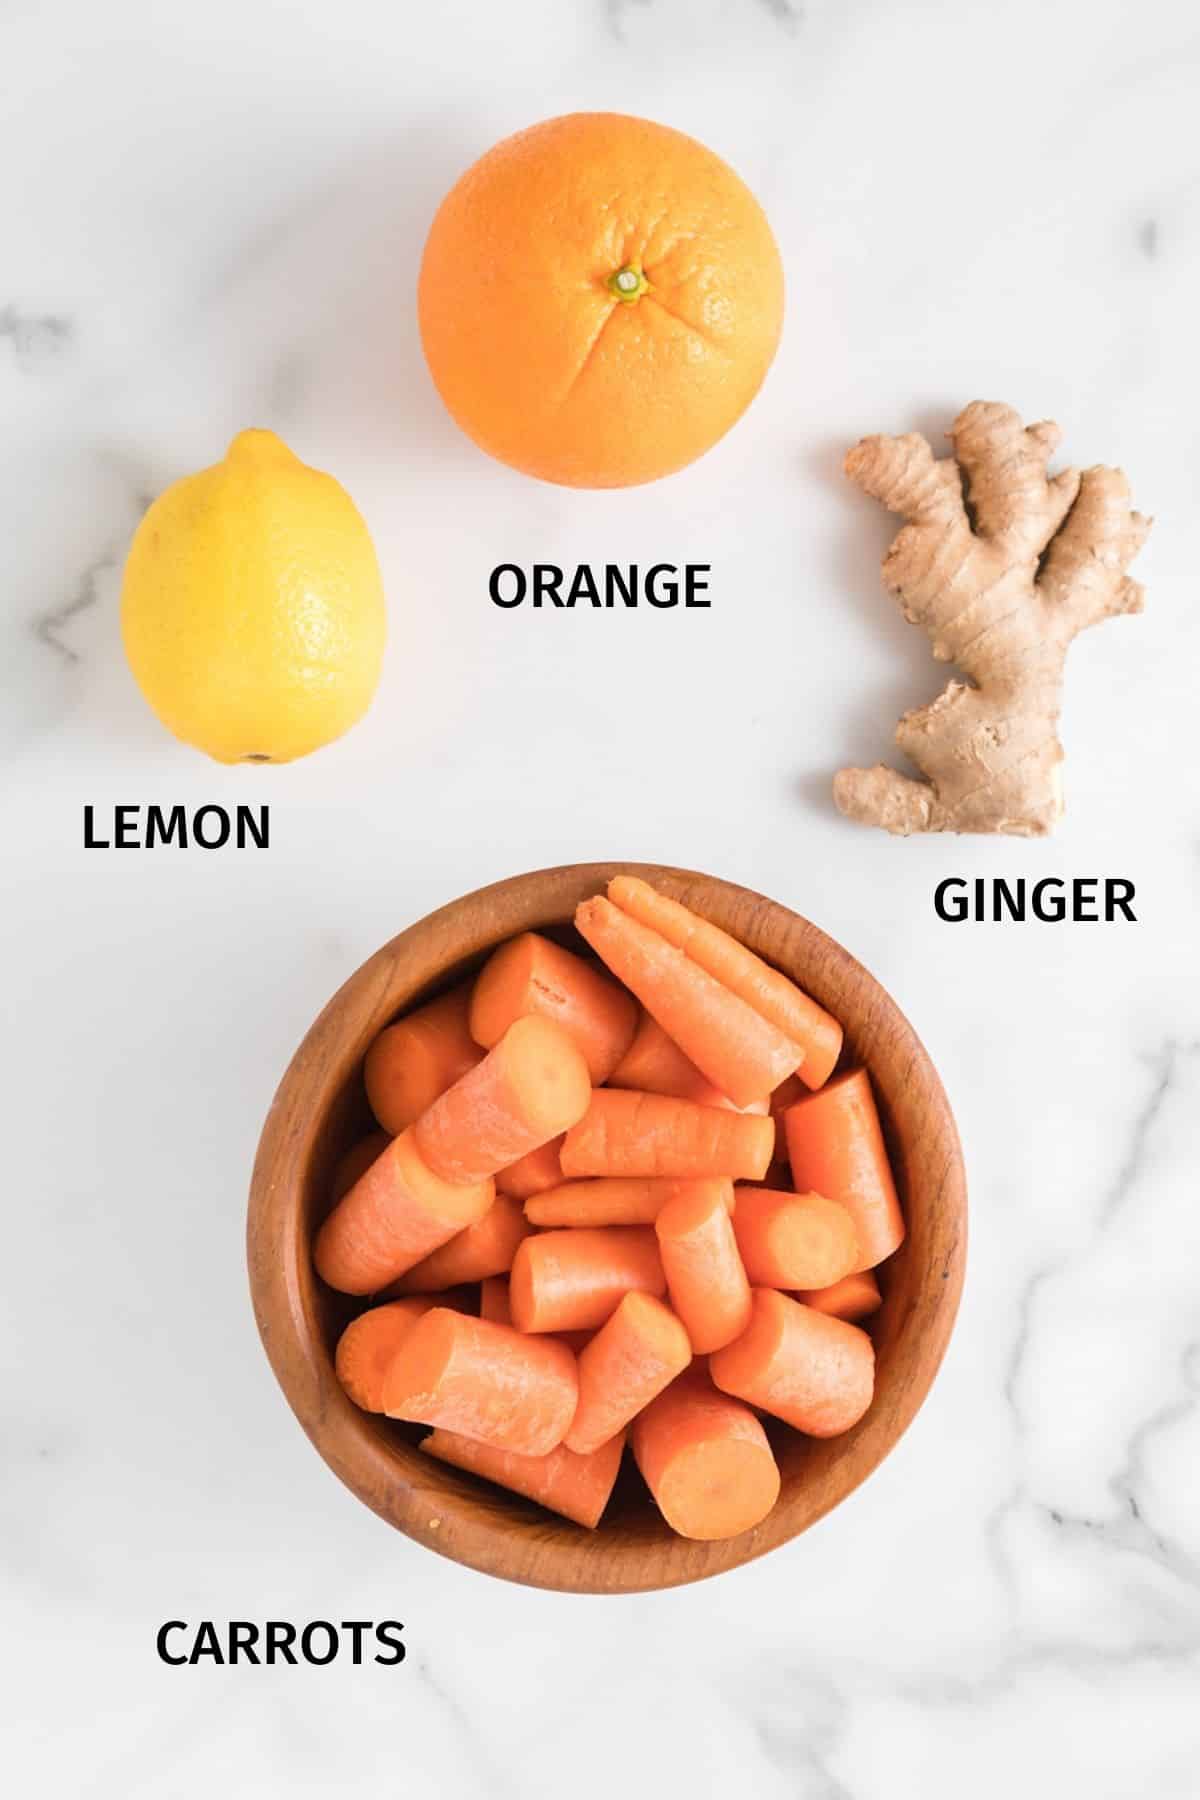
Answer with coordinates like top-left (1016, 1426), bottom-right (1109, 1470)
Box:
top-left (121, 430), bottom-right (385, 763)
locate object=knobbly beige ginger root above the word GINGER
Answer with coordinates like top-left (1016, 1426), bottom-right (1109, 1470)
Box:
top-left (833, 400), bottom-right (1150, 837)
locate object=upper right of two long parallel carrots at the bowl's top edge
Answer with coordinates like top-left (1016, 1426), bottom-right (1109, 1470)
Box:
top-left (608, 875), bottom-right (842, 1093)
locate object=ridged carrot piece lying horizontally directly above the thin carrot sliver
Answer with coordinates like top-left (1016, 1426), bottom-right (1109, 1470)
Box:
top-left (560, 1087), bottom-right (775, 1181)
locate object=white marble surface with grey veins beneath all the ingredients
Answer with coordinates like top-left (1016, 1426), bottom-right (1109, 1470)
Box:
top-left (0, 0), bottom-right (1200, 1800)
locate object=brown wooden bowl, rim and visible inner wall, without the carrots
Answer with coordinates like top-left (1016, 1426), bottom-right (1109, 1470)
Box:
top-left (248, 862), bottom-right (966, 1593)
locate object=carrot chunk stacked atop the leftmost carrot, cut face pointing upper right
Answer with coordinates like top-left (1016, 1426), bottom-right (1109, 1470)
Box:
top-left (412, 1019), bottom-right (592, 1183)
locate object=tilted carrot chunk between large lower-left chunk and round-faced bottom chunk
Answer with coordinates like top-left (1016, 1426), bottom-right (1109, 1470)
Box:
top-left (563, 1292), bottom-right (691, 1456)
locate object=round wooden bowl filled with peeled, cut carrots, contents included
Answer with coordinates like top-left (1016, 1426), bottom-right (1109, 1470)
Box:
top-left (248, 864), bottom-right (966, 1593)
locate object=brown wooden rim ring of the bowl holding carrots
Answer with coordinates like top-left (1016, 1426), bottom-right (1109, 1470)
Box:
top-left (246, 860), bottom-right (966, 1593)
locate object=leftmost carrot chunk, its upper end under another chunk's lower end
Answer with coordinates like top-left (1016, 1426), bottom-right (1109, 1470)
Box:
top-left (313, 1130), bottom-right (495, 1294)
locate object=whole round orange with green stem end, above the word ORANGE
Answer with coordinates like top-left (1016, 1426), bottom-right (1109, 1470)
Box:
top-left (419, 113), bottom-right (783, 488)
